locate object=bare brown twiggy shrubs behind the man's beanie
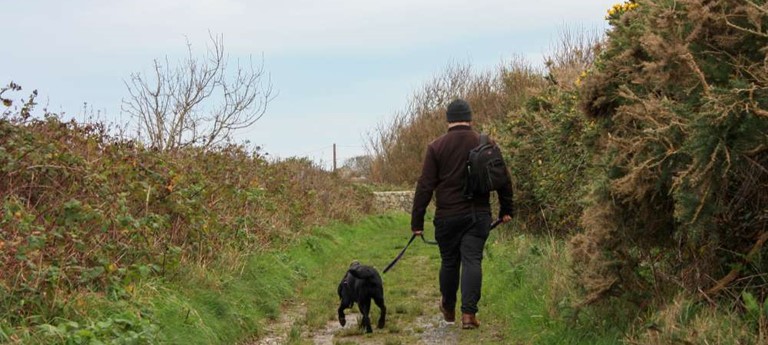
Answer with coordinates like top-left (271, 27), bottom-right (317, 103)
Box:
top-left (366, 60), bottom-right (540, 186)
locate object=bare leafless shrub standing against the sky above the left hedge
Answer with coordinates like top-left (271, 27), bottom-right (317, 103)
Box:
top-left (123, 36), bottom-right (273, 151)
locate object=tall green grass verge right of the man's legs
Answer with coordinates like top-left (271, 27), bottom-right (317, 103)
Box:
top-left (483, 227), bottom-right (630, 345)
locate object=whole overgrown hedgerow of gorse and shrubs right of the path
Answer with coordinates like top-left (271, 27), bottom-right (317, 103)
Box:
top-left (364, 0), bottom-right (768, 344)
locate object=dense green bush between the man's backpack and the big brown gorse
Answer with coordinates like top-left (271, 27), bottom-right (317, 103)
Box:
top-left (500, 84), bottom-right (597, 235)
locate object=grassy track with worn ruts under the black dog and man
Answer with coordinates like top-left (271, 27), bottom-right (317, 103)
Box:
top-left (243, 214), bottom-right (510, 344)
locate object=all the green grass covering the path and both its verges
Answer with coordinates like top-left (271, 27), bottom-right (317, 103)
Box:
top-left (14, 213), bottom-right (622, 344)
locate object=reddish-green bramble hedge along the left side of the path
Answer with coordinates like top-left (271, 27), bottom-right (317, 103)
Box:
top-left (0, 85), bottom-right (370, 336)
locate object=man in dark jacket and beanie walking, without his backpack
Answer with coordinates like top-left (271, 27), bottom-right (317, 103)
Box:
top-left (411, 99), bottom-right (512, 329)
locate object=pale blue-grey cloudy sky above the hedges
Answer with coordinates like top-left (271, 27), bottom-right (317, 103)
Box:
top-left (0, 0), bottom-right (615, 168)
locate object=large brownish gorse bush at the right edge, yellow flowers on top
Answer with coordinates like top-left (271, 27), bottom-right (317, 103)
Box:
top-left (572, 0), bottom-right (768, 300)
